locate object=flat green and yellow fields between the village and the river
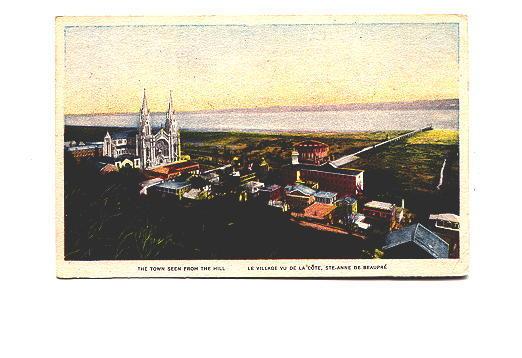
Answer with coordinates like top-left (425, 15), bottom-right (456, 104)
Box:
top-left (65, 127), bottom-right (459, 215)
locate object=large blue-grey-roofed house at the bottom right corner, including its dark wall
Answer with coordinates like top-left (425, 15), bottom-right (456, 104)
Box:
top-left (382, 224), bottom-right (449, 259)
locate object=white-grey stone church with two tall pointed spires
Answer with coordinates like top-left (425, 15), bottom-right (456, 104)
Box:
top-left (103, 90), bottom-right (181, 169)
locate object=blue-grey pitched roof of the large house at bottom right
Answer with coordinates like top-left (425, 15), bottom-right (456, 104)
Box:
top-left (383, 224), bottom-right (449, 259)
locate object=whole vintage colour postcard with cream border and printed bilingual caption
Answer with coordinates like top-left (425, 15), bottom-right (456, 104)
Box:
top-left (56, 15), bottom-right (469, 278)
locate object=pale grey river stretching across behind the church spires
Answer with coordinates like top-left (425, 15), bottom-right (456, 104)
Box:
top-left (65, 109), bottom-right (458, 132)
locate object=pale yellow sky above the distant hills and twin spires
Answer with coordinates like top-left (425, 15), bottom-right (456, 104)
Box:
top-left (64, 23), bottom-right (459, 114)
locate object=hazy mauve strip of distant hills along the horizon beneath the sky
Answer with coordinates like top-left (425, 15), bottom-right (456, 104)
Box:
top-left (64, 98), bottom-right (460, 116)
